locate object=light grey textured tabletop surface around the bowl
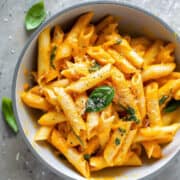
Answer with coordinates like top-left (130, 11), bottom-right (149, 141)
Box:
top-left (0, 0), bottom-right (180, 180)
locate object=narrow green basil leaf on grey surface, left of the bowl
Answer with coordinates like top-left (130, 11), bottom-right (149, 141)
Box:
top-left (2, 97), bottom-right (18, 133)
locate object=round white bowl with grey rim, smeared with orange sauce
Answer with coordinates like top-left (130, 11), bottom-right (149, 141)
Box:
top-left (12, 1), bottom-right (180, 180)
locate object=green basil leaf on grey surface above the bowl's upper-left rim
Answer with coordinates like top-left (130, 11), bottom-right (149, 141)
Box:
top-left (25, 1), bottom-right (46, 30)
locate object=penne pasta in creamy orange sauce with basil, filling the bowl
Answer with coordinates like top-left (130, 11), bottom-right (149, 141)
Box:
top-left (13, 2), bottom-right (180, 178)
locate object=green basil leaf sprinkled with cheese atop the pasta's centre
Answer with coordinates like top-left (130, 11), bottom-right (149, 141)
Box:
top-left (86, 86), bottom-right (114, 112)
